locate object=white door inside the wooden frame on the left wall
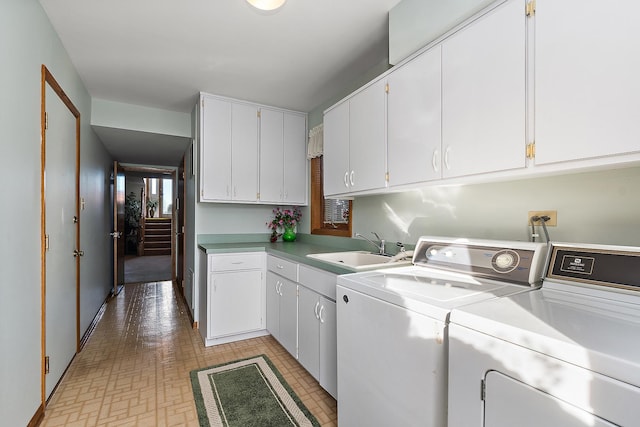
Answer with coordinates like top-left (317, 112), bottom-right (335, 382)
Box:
top-left (44, 85), bottom-right (78, 398)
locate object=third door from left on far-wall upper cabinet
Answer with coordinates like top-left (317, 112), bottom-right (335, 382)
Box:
top-left (260, 108), bottom-right (284, 203)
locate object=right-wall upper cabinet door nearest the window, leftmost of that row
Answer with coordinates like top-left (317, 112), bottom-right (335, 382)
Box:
top-left (322, 101), bottom-right (349, 196)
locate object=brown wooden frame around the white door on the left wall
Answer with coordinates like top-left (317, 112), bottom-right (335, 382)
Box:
top-left (38, 64), bottom-right (80, 408)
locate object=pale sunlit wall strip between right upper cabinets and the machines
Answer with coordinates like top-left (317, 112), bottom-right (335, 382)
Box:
top-left (353, 167), bottom-right (640, 246)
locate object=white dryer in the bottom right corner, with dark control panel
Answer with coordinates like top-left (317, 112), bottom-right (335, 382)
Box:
top-left (449, 243), bottom-right (640, 427)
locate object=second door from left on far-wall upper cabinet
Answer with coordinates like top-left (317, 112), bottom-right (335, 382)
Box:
top-left (231, 103), bottom-right (258, 202)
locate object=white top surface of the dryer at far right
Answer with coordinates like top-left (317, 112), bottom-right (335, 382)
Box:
top-left (451, 288), bottom-right (640, 386)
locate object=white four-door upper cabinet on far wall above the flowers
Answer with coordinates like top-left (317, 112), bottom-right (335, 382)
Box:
top-left (200, 94), bottom-right (308, 205)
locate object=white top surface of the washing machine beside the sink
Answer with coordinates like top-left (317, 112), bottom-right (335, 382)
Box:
top-left (338, 266), bottom-right (531, 321)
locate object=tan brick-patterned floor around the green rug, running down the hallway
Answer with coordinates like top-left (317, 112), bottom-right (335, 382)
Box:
top-left (41, 281), bottom-right (337, 427)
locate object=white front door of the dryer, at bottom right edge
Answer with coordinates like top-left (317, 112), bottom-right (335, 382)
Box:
top-left (483, 371), bottom-right (617, 427)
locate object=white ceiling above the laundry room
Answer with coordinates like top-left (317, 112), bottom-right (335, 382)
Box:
top-left (40, 0), bottom-right (399, 112)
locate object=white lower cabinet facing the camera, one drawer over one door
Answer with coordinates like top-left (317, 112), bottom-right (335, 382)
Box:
top-left (199, 252), bottom-right (267, 346)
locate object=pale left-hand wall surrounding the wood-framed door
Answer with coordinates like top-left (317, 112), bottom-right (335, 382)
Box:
top-left (0, 0), bottom-right (111, 426)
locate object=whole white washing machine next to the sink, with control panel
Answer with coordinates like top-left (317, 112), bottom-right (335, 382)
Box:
top-left (336, 237), bottom-right (547, 427)
